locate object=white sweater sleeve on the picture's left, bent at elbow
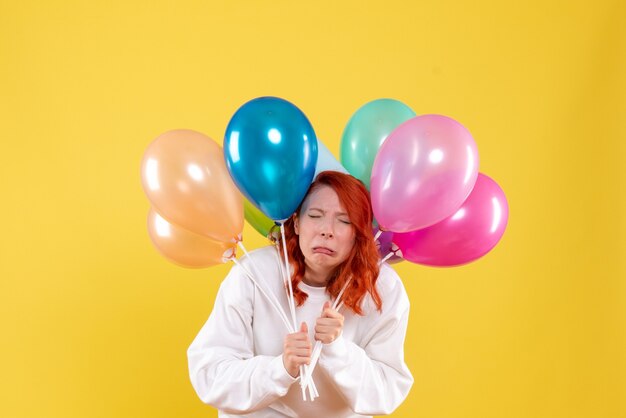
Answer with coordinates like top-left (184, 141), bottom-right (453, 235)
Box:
top-left (187, 266), bottom-right (296, 414)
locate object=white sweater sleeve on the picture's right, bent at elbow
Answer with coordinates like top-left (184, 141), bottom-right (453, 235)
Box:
top-left (319, 267), bottom-right (413, 415)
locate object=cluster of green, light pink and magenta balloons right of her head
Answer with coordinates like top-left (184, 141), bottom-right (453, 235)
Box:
top-left (341, 99), bottom-right (508, 267)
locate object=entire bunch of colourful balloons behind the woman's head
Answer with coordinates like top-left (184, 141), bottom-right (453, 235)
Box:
top-left (141, 97), bottom-right (508, 267)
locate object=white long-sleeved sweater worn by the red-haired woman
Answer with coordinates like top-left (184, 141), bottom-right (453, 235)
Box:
top-left (187, 247), bottom-right (413, 418)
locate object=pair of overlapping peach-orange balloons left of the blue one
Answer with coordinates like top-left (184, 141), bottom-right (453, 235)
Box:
top-left (141, 129), bottom-right (243, 268)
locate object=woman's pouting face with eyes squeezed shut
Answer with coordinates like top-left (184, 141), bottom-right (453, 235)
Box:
top-left (295, 186), bottom-right (355, 276)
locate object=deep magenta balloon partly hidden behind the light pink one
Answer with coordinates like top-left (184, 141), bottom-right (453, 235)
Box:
top-left (393, 173), bottom-right (509, 267)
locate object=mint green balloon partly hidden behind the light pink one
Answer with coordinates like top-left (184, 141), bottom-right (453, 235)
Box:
top-left (340, 99), bottom-right (415, 189)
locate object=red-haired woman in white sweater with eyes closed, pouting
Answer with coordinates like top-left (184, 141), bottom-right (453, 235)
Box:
top-left (187, 171), bottom-right (413, 418)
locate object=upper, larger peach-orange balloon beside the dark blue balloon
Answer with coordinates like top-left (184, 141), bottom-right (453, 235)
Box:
top-left (141, 129), bottom-right (243, 241)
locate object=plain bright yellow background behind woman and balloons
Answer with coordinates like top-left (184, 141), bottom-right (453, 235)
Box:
top-left (0, 0), bottom-right (626, 418)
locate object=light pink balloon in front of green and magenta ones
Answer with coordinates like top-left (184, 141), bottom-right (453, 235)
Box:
top-left (371, 115), bottom-right (478, 232)
